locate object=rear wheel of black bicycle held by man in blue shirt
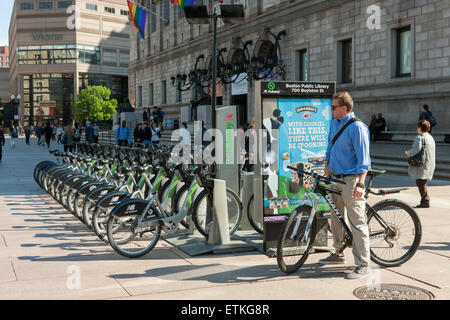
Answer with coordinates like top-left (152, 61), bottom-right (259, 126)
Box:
top-left (367, 199), bottom-right (422, 267)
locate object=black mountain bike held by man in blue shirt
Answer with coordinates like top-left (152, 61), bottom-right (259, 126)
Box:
top-left (277, 167), bottom-right (422, 273)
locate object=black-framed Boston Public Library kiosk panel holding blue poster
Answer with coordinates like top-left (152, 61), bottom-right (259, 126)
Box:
top-left (254, 81), bottom-right (336, 257)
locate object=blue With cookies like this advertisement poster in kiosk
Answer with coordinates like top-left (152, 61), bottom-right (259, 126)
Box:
top-left (263, 98), bottom-right (332, 221)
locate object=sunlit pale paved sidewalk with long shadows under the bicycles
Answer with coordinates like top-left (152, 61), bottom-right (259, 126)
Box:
top-left (0, 139), bottom-right (450, 300)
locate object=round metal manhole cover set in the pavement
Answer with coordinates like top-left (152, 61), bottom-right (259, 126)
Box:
top-left (353, 283), bottom-right (434, 300)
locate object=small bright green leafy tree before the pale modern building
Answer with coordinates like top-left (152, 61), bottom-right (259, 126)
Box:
top-left (72, 86), bottom-right (117, 121)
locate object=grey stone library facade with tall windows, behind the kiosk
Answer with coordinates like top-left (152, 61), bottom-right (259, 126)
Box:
top-left (129, 0), bottom-right (450, 131)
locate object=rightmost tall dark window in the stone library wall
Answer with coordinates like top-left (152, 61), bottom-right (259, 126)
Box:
top-left (396, 26), bottom-right (411, 77)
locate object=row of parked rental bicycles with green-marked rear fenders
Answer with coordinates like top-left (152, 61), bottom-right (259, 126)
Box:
top-left (34, 144), bottom-right (246, 258)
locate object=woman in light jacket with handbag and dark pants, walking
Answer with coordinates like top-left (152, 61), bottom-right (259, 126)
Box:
top-left (405, 120), bottom-right (436, 208)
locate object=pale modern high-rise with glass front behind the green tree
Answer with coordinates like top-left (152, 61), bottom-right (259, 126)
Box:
top-left (9, 0), bottom-right (130, 125)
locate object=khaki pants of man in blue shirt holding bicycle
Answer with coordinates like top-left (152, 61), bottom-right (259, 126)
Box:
top-left (331, 175), bottom-right (370, 267)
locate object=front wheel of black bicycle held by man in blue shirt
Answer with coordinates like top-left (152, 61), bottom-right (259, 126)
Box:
top-left (277, 205), bottom-right (317, 273)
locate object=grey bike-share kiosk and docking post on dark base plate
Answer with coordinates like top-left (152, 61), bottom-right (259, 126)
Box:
top-left (162, 106), bottom-right (262, 256)
